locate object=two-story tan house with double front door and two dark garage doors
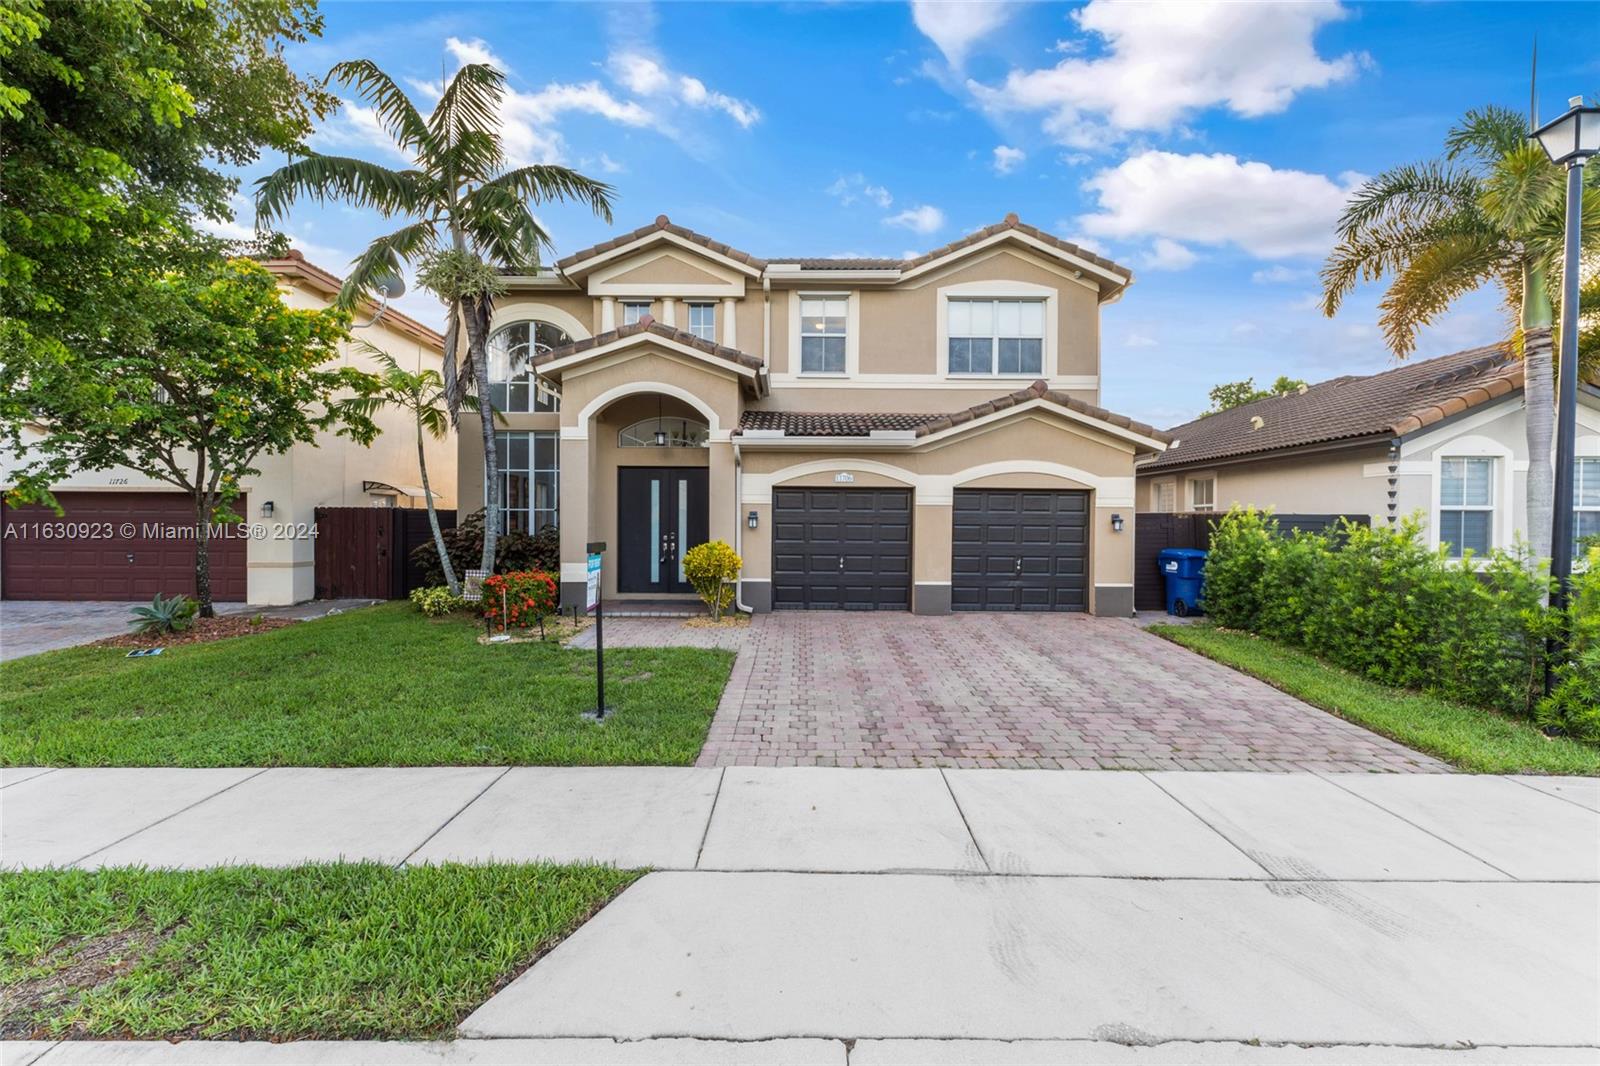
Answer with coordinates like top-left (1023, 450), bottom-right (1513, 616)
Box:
top-left (458, 214), bottom-right (1165, 615)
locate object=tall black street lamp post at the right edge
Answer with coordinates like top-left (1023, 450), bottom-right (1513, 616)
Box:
top-left (1530, 96), bottom-right (1600, 627)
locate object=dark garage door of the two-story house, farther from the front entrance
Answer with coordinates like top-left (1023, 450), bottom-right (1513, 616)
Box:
top-left (950, 490), bottom-right (1090, 611)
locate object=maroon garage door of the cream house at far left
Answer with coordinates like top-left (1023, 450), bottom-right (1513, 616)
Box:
top-left (0, 493), bottom-right (250, 602)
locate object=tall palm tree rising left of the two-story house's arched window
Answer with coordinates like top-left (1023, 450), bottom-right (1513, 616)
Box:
top-left (256, 59), bottom-right (611, 571)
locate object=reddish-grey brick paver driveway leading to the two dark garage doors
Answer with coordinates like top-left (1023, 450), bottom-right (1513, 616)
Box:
top-left (652, 611), bottom-right (1448, 771)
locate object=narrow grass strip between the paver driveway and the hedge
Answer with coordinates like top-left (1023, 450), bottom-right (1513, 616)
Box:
top-left (1150, 624), bottom-right (1600, 775)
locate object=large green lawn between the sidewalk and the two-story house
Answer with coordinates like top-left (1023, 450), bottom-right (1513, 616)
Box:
top-left (0, 603), bottom-right (733, 767)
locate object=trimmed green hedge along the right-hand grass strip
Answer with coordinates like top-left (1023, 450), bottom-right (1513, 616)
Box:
top-left (1205, 509), bottom-right (1600, 741)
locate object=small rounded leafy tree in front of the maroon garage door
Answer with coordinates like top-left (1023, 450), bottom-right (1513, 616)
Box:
top-left (5, 259), bottom-right (378, 618)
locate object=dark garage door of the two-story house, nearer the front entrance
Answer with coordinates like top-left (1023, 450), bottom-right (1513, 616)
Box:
top-left (773, 488), bottom-right (910, 611)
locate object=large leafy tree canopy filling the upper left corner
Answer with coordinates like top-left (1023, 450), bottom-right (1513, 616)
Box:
top-left (0, 0), bottom-right (336, 448)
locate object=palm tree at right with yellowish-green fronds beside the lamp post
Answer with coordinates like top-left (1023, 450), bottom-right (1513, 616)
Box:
top-left (1322, 107), bottom-right (1600, 557)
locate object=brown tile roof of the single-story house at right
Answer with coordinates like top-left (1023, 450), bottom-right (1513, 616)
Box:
top-left (1139, 344), bottom-right (1522, 474)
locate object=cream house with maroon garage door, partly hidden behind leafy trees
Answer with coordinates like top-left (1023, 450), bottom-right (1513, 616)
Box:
top-left (0, 251), bottom-right (456, 603)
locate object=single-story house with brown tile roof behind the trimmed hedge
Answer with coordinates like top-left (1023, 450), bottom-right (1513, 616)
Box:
top-left (1139, 344), bottom-right (1600, 555)
